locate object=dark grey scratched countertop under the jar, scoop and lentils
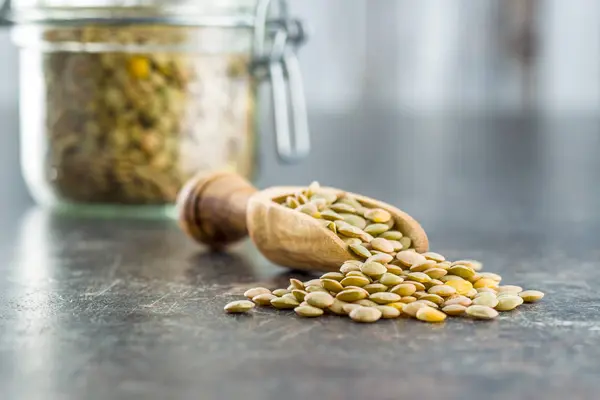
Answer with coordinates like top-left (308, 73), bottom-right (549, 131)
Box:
top-left (0, 115), bottom-right (600, 400)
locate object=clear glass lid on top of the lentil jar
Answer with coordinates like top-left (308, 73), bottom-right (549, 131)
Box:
top-left (0, 0), bottom-right (269, 26)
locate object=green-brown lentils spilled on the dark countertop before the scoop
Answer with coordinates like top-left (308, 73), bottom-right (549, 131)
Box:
top-left (225, 255), bottom-right (544, 322)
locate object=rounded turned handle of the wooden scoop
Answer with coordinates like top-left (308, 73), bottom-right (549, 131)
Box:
top-left (177, 172), bottom-right (257, 249)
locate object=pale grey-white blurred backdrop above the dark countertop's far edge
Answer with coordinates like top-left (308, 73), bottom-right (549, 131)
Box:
top-left (0, 0), bottom-right (600, 206)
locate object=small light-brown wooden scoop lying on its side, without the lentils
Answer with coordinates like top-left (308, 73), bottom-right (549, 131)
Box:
top-left (177, 172), bottom-right (429, 271)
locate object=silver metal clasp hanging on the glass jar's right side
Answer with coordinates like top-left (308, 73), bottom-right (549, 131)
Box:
top-left (253, 0), bottom-right (310, 163)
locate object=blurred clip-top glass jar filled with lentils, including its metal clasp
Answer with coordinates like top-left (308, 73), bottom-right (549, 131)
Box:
top-left (4, 0), bottom-right (309, 215)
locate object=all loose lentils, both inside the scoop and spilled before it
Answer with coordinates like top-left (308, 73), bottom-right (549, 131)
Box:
top-left (225, 183), bottom-right (544, 323)
